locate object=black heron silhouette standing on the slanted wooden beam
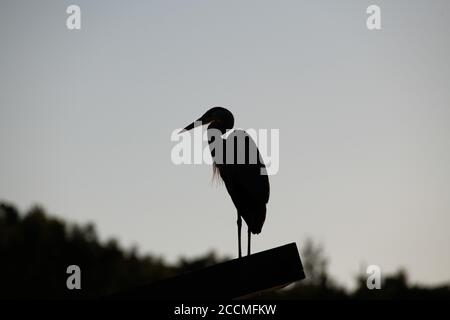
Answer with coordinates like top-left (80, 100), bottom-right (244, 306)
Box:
top-left (180, 107), bottom-right (270, 258)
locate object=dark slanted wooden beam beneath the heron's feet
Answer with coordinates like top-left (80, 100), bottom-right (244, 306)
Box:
top-left (108, 243), bottom-right (305, 301)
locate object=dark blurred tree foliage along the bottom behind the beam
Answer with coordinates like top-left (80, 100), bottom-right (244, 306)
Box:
top-left (0, 203), bottom-right (450, 299)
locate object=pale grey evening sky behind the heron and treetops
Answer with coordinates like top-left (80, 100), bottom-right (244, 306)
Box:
top-left (0, 0), bottom-right (450, 284)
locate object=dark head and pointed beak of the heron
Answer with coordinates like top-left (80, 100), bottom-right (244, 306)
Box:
top-left (180, 107), bottom-right (234, 134)
